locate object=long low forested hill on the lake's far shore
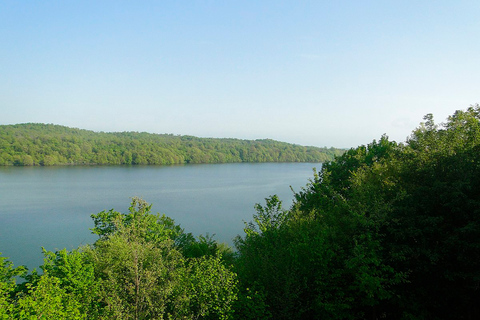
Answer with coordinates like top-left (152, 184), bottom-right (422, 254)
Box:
top-left (0, 123), bottom-right (343, 166)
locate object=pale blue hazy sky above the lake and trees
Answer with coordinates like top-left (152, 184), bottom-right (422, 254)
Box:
top-left (0, 0), bottom-right (480, 147)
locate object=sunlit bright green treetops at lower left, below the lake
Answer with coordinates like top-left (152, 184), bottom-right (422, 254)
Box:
top-left (0, 198), bottom-right (238, 320)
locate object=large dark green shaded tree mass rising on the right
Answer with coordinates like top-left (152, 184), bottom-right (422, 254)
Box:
top-left (236, 105), bottom-right (480, 319)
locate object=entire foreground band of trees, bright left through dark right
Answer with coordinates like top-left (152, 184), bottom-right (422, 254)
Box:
top-left (0, 105), bottom-right (480, 319)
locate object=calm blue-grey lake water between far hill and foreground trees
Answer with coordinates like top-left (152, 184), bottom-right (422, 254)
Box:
top-left (0, 163), bottom-right (321, 269)
